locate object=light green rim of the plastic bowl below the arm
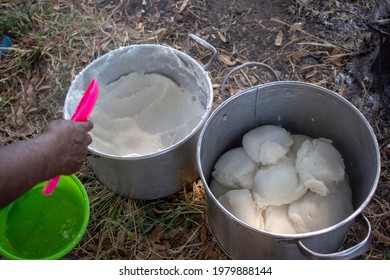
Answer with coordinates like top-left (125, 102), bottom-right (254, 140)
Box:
top-left (0, 174), bottom-right (90, 260)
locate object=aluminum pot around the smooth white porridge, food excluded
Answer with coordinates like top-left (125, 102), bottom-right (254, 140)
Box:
top-left (64, 34), bottom-right (217, 199)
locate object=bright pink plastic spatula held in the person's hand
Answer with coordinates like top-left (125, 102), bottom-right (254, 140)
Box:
top-left (42, 79), bottom-right (99, 195)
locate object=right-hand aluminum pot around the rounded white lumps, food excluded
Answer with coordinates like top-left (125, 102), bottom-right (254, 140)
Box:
top-left (197, 64), bottom-right (380, 259)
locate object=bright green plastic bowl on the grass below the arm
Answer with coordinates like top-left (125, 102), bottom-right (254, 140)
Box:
top-left (0, 175), bottom-right (90, 260)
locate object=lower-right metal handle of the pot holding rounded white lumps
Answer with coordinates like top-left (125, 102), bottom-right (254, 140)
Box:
top-left (297, 214), bottom-right (371, 260)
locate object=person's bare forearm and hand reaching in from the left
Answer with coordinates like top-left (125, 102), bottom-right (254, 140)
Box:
top-left (0, 120), bottom-right (93, 209)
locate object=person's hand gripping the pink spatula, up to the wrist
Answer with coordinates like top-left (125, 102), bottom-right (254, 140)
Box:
top-left (42, 119), bottom-right (93, 175)
